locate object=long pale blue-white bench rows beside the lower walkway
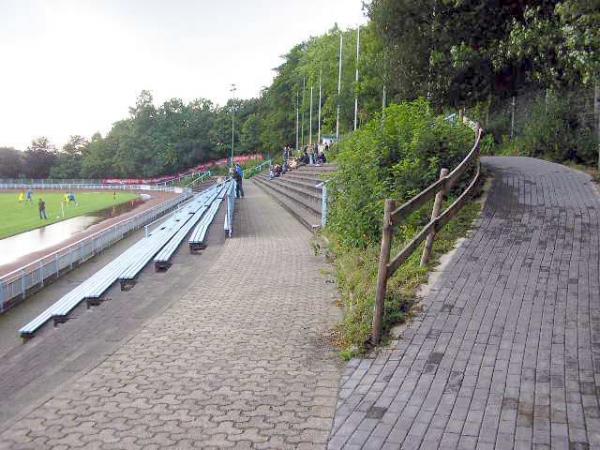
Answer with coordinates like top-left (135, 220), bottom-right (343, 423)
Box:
top-left (19, 181), bottom-right (233, 338)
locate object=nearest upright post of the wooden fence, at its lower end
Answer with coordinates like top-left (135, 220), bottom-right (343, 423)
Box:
top-left (371, 199), bottom-right (395, 345)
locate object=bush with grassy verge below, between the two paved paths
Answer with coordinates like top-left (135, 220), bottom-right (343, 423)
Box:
top-left (325, 100), bottom-right (479, 358)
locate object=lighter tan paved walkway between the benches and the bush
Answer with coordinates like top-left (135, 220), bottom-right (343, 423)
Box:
top-left (0, 183), bottom-right (343, 449)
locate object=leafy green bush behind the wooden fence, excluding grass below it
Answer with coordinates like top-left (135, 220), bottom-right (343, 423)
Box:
top-left (328, 100), bottom-right (474, 248)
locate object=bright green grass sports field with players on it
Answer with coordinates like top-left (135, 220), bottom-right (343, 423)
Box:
top-left (0, 191), bottom-right (137, 239)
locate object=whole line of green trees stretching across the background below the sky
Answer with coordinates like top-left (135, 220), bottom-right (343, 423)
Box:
top-left (0, 0), bottom-right (600, 178)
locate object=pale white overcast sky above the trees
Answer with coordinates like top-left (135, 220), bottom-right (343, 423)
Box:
top-left (0, 0), bottom-right (367, 150)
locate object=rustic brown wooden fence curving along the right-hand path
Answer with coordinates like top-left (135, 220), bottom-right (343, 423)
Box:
top-left (371, 126), bottom-right (482, 345)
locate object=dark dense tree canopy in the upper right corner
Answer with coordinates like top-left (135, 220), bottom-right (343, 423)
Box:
top-left (369, 0), bottom-right (600, 107)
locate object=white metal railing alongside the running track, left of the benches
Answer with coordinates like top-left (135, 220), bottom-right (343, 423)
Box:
top-left (0, 191), bottom-right (191, 313)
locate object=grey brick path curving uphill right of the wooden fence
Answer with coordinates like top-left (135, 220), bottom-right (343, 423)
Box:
top-left (329, 158), bottom-right (600, 449)
